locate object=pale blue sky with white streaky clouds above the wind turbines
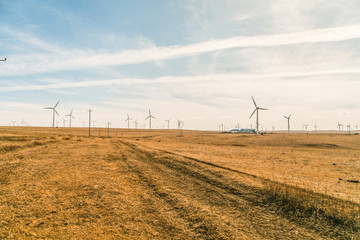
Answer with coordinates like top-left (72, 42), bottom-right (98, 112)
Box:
top-left (0, 0), bottom-right (360, 130)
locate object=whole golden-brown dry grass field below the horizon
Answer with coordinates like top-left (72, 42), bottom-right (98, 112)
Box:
top-left (0, 127), bottom-right (360, 239)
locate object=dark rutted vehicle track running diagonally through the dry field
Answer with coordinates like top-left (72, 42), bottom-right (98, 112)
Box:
top-left (114, 141), bottom-right (332, 239)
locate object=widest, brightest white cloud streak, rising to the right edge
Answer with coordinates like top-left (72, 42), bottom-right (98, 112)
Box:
top-left (3, 25), bottom-right (360, 74)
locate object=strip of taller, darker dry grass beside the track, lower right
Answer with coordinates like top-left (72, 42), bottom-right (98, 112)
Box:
top-left (263, 181), bottom-right (360, 239)
